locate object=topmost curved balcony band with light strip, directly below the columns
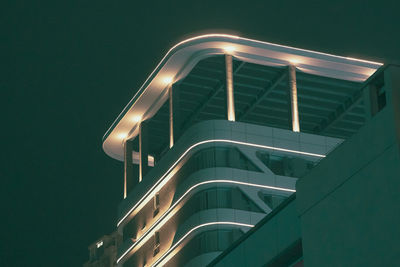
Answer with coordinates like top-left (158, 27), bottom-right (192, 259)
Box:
top-left (118, 120), bottom-right (342, 226)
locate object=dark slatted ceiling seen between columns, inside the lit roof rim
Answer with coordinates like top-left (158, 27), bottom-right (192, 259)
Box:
top-left (136, 55), bottom-right (374, 158)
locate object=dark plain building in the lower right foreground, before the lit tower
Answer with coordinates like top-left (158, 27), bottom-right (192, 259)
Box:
top-left (209, 65), bottom-right (400, 267)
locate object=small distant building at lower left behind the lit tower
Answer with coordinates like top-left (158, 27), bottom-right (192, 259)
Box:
top-left (83, 232), bottom-right (122, 267)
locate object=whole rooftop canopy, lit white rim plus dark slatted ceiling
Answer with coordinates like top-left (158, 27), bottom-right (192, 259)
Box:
top-left (103, 35), bottom-right (382, 160)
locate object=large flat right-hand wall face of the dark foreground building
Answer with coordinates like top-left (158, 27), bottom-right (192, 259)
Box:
top-left (296, 67), bottom-right (400, 267)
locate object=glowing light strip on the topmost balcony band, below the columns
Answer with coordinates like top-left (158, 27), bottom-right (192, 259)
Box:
top-left (117, 139), bottom-right (325, 227)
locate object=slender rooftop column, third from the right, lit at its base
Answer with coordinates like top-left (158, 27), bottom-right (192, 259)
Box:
top-left (168, 84), bottom-right (181, 148)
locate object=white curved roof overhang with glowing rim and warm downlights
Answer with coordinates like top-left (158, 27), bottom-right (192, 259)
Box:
top-left (103, 34), bottom-right (383, 160)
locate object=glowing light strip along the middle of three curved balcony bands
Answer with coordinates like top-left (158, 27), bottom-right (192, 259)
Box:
top-left (117, 180), bottom-right (296, 263)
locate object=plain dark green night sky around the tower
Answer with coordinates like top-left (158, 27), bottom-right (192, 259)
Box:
top-left (0, 0), bottom-right (400, 266)
